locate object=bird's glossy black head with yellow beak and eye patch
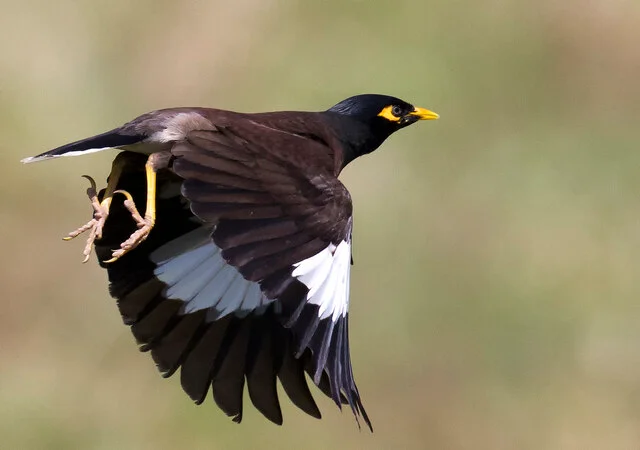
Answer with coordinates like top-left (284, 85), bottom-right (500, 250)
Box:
top-left (327, 94), bottom-right (439, 165)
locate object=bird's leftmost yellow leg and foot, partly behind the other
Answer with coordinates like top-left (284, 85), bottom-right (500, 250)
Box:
top-left (63, 155), bottom-right (125, 263)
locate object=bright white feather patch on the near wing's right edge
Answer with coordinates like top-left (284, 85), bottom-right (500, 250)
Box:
top-left (292, 241), bottom-right (351, 322)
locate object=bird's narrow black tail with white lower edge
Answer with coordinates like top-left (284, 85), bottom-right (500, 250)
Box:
top-left (21, 128), bottom-right (147, 163)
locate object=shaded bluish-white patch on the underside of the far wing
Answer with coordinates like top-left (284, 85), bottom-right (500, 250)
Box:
top-left (150, 227), bottom-right (273, 319)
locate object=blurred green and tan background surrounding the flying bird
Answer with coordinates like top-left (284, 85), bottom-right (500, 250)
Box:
top-left (0, 0), bottom-right (640, 450)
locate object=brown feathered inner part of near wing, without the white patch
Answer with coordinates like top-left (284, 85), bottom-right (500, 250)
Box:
top-left (172, 127), bottom-right (352, 298)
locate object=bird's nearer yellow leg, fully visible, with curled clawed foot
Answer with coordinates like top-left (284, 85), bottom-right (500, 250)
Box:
top-left (104, 152), bottom-right (171, 263)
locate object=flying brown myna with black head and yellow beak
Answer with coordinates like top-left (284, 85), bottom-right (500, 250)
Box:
top-left (22, 94), bottom-right (439, 431)
